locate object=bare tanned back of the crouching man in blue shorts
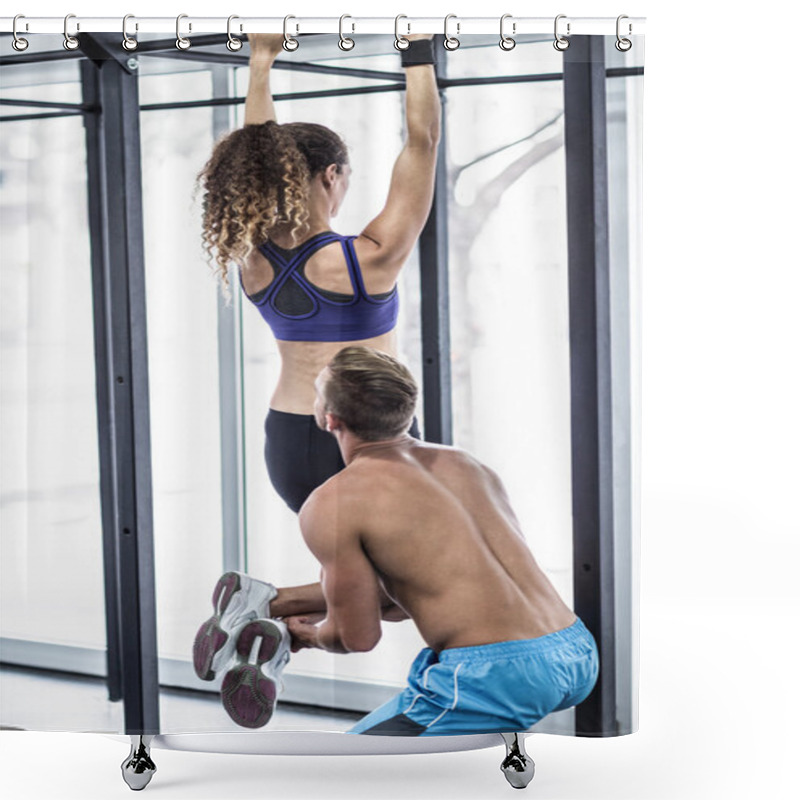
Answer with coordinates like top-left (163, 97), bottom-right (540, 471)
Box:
top-left (301, 436), bottom-right (576, 651)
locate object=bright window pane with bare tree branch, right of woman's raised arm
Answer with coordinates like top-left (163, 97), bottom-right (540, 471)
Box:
top-left (447, 43), bottom-right (572, 603)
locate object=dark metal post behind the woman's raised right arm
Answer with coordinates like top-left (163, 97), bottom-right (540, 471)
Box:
top-left (419, 36), bottom-right (453, 444)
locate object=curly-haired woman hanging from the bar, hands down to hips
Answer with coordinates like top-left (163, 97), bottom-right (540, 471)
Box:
top-left (200, 34), bottom-right (441, 511)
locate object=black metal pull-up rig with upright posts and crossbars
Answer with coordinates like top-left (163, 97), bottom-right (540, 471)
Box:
top-left (0, 34), bottom-right (643, 736)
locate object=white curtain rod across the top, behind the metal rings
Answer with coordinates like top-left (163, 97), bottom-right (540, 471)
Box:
top-left (0, 14), bottom-right (645, 36)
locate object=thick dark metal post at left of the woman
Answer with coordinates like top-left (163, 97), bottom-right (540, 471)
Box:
top-left (80, 34), bottom-right (159, 734)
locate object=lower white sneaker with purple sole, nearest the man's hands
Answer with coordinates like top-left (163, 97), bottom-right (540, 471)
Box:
top-left (221, 619), bottom-right (291, 728)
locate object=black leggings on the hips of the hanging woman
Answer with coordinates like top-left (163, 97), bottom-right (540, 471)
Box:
top-left (264, 408), bottom-right (420, 513)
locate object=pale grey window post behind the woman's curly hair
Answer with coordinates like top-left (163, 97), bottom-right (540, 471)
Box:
top-left (211, 66), bottom-right (247, 571)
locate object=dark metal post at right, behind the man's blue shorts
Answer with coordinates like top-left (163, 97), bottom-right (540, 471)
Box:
top-left (564, 36), bottom-right (618, 736)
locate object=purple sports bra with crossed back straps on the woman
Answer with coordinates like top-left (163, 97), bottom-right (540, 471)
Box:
top-left (245, 231), bottom-right (399, 342)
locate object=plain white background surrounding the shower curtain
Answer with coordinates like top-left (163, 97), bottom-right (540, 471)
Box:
top-left (0, 0), bottom-right (800, 800)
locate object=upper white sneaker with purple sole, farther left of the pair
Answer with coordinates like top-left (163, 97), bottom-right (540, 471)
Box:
top-left (192, 572), bottom-right (278, 681)
